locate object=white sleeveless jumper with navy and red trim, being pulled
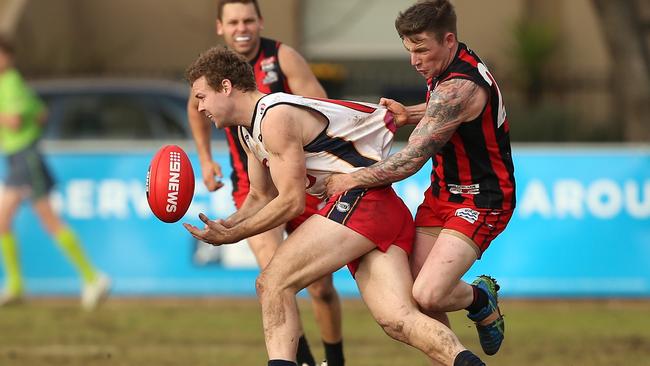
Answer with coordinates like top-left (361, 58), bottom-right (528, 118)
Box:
top-left (239, 93), bottom-right (395, 198)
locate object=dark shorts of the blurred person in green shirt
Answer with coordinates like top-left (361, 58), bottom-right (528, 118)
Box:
top-left (5, 145), bottom-right (54, 199)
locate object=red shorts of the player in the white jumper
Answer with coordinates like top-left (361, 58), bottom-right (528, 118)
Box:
top-left (318, 187), bottom-right (415, 276)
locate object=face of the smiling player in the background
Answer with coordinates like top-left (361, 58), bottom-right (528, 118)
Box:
top-left (217, 3), bottom-right (264, 60)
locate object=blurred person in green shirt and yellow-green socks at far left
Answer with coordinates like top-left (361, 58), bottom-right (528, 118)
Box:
top-left (0, 37), bottom-right (110, 310)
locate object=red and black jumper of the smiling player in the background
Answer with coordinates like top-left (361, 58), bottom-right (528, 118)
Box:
top-left (224, 38), bottom-right (291, 207)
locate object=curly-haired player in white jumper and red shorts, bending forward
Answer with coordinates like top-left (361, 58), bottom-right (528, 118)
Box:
top-left (184, 48), bottom-right (484, 366)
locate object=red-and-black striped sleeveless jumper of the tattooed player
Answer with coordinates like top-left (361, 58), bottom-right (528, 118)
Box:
top-left (427, 43), bottom-right (515, 210)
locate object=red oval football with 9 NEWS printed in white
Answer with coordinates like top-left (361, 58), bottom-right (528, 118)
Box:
top-left (147, 145), bottom-right (194, 222)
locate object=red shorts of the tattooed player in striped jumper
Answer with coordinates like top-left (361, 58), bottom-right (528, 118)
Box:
top-left (415, 190), bottom-right (512, 258)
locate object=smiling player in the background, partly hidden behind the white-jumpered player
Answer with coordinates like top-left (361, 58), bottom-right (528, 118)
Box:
top-left (188, 0), bottom-right (344, 366)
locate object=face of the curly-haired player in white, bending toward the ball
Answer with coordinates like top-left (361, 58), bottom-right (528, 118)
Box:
top-left (192, 76), bottom-right (232, 128)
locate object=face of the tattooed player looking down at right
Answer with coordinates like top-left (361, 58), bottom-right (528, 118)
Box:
top-left (402, 32), bottom-right (456, 79)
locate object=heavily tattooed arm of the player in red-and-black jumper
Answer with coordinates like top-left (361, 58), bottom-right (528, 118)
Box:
top-left (327, 79), bottom-right (488, 195)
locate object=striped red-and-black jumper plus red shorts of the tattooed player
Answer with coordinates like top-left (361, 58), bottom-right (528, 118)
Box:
top-left (416, 43), bottom-right (515, 253)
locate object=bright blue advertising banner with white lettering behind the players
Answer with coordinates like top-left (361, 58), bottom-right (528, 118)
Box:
top-left (0, 147), bottom-right (650, 297)
